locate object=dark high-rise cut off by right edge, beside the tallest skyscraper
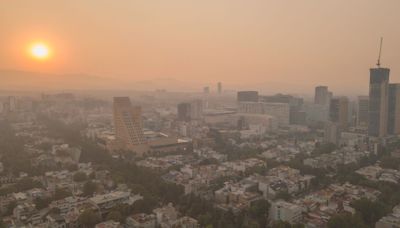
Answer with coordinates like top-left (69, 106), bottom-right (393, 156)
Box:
top-left (388, 83), bottom-right (400, 135)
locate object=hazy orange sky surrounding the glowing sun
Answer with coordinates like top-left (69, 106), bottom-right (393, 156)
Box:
top-left (0, 0), bottom-right (400, 93)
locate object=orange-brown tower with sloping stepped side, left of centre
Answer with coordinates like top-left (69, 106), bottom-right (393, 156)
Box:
top-left (113, 97), bottom-right (146, 152)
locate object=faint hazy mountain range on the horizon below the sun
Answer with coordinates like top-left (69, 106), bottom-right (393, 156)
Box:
top-left (0, 69), bottom-right (214, 92)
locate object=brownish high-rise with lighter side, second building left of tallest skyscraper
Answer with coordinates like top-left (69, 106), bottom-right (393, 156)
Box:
top-left (329, 97), bottom-right (349, 130)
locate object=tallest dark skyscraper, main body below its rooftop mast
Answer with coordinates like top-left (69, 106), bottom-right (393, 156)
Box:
top-left (368, 65), bottom-right (390, 137)
